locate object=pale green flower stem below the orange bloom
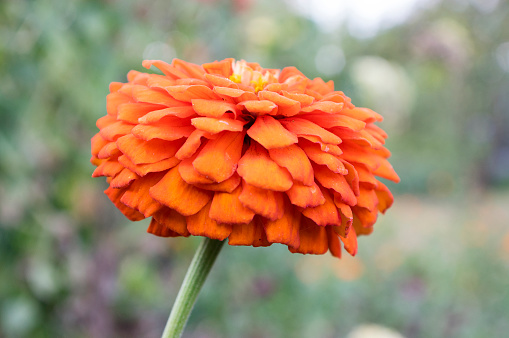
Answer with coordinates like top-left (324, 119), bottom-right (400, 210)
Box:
top-left (161, 237), bottom-right (224, 338)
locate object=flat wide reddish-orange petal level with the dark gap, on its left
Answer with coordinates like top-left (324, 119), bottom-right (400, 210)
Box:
top-left (131, 121), bottom-right (195, 141)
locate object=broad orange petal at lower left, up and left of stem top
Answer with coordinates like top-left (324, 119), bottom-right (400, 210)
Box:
top-left (150, 167), bottom-right (211, 216)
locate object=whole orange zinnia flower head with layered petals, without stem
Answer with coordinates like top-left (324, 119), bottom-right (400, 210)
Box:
top-left (91, 59), bottom-right (399, 257)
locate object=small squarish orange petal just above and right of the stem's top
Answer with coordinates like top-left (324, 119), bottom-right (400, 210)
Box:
top-left (209, 186), bottom-right (255, 224)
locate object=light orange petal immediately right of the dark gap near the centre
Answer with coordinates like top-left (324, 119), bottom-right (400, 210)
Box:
top-left (247, 116), bottom-right (298, 149)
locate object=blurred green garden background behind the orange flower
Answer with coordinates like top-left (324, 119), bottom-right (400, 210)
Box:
top-left (0, 0), bottom-right (509, 338)
